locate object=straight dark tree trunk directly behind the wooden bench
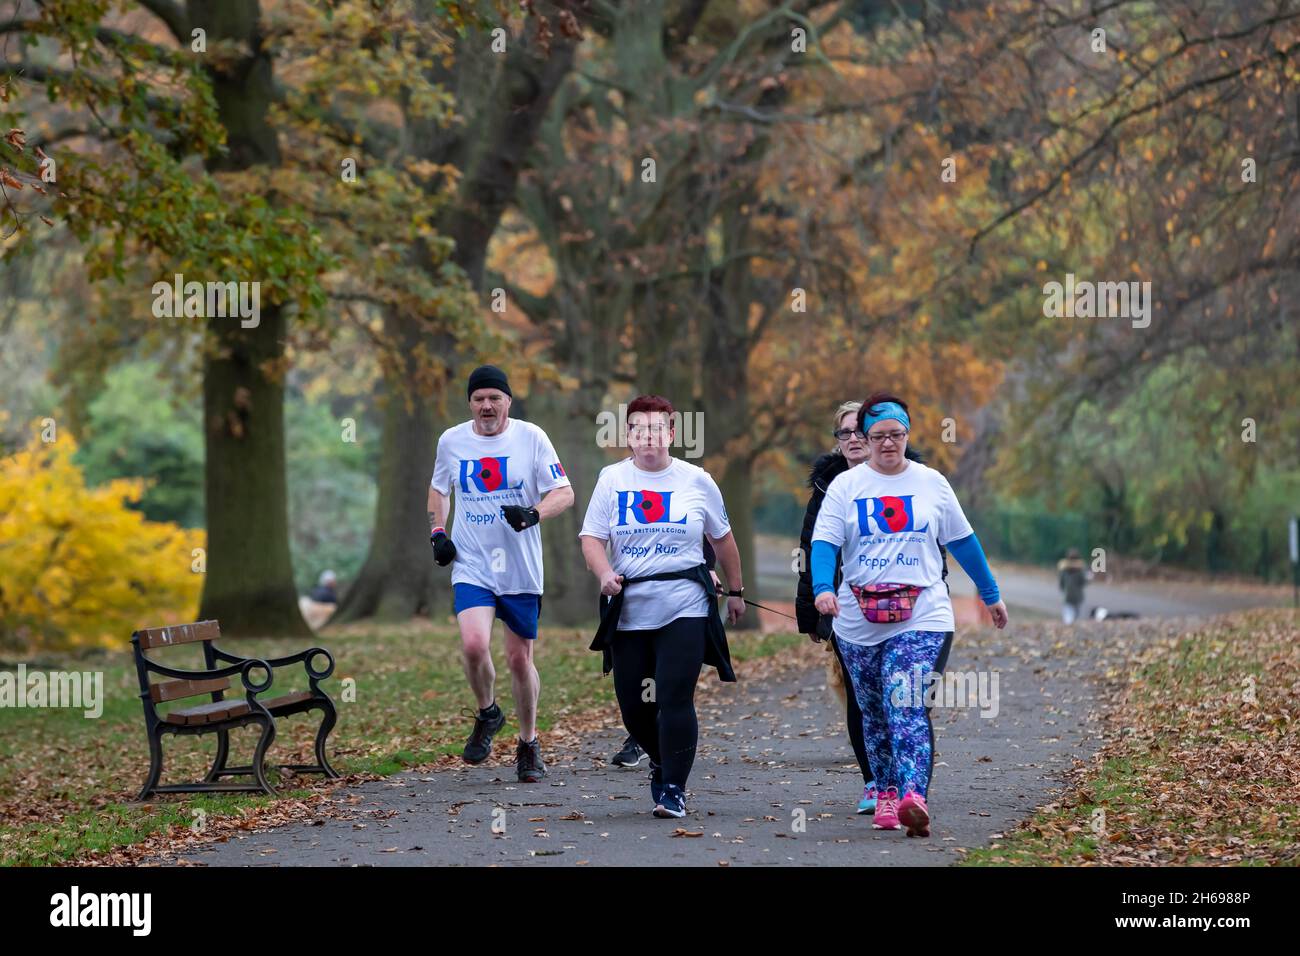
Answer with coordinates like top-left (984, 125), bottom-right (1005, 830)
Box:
top-left (187, 0), bottom-right (311, 636)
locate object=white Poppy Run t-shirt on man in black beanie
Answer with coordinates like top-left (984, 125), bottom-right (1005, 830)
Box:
top-left (429, 419), bottom-right (569, 594)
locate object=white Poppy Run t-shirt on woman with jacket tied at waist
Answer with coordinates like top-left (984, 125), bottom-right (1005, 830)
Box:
top-left (579, 458), bottom-right (731, 631)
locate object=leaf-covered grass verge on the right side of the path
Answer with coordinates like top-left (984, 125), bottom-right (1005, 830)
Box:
top-left (965, 610), bottom-right (1300, 866)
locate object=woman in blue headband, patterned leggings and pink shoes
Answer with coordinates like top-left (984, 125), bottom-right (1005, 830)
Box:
top-left (810, 393), bottom-right (1006, 836)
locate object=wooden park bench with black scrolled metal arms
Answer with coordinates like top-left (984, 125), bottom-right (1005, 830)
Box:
top-left (131, 620), bottom-right (338, 800)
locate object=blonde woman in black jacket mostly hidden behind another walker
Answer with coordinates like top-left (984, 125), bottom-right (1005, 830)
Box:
top-left (794, 402), bottom-right (948, 813)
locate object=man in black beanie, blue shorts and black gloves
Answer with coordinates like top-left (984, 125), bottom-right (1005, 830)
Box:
top-left (429, 365), bottom-right (573, 783)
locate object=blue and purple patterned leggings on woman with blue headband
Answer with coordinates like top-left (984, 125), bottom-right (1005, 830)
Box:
top-left (840, 631), bottom-right (953, 796)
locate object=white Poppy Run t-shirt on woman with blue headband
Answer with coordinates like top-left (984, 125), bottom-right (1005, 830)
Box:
top-left (813, 462), bottom-right (972, 645)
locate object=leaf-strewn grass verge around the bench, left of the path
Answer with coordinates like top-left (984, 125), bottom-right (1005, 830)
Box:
top-left (0, 622), bottom-right (803, 866)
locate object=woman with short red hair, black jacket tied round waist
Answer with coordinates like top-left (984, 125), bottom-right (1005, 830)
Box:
top-left (580, 395), bottom-right (745, 817)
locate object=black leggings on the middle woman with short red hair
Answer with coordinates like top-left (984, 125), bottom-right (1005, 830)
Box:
top-left (611, 618), bottom-right (707, 788)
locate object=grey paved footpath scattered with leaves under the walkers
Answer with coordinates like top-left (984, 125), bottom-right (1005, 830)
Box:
top-left (165, 620), bottom-right (1187, 866)
